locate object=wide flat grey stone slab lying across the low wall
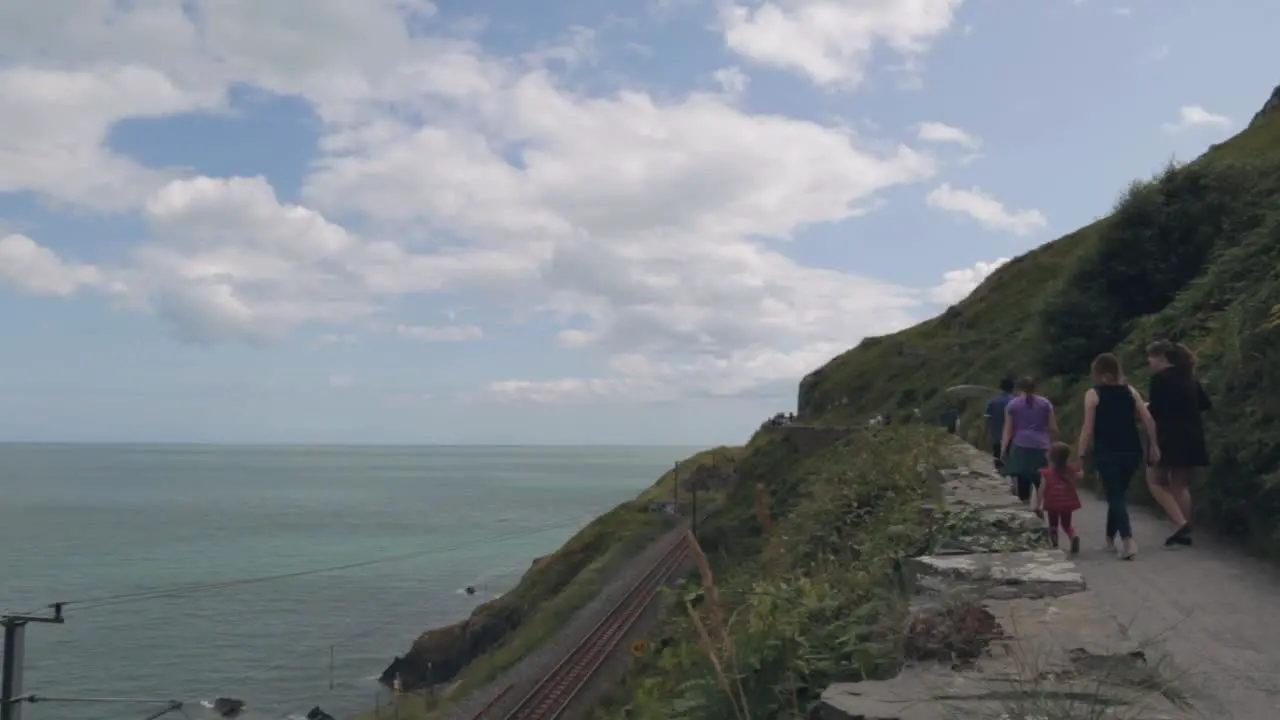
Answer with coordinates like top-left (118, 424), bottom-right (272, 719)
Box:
top-left (905, 550), bottom-right (1085, 600)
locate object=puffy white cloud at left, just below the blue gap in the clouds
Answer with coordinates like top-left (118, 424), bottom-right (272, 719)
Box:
top-left (6, 177), bottom-right (522, 342)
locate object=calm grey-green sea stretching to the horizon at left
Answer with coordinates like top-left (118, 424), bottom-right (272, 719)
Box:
top-left (0, 445), bottom-right (695, 720)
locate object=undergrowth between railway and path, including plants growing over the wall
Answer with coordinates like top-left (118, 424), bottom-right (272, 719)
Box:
top-left (596, 425), bottom-right (1044, 720)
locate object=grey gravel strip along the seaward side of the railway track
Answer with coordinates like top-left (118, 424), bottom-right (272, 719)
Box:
top-left (444, 523), bottom-right (687, 720)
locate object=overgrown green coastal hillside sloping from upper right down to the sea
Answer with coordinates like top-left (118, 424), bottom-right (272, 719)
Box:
top-left (371, 81), bottom-right (1280, 719)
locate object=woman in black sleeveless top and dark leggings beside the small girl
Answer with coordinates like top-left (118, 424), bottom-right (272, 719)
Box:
top-left (1076, 352), bottom-right (1161, 560)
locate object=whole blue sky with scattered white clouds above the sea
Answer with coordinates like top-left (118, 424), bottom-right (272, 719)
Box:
top-left (0, 0), bottom-right (1280, 445)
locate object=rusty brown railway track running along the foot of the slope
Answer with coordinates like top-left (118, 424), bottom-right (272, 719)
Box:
top-left (477, 534), bottom-right (689, 720)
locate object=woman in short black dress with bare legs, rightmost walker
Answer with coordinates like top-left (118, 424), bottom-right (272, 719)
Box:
top-left (1147, 340), bottom-right (1213, 547)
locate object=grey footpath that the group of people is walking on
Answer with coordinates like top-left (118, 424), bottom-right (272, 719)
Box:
top-left (1074, 493), bottom-right (1280, 720)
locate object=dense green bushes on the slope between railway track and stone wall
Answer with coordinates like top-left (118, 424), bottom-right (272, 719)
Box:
top-left (622, 428), bottom-right (941, 720)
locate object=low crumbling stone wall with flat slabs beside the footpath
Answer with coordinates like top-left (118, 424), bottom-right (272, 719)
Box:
top-left (819, 443), bottom-right (1190, 720)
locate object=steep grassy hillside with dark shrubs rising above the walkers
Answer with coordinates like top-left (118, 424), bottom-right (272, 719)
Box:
top-left (800, 83), bottom-right (1280, 551)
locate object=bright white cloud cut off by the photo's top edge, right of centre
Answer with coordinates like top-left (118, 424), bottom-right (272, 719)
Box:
top-left (721, 0), bottom-right (961, 87)
